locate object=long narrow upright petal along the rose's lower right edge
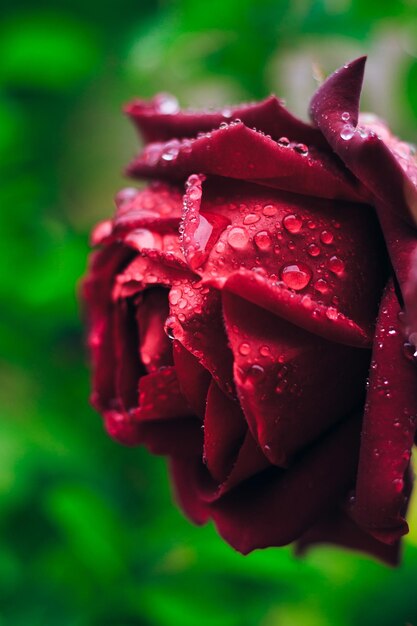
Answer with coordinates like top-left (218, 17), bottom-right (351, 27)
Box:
top-left (352, 283), bottom-right (417, 544)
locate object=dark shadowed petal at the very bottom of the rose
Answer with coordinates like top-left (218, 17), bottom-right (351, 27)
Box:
top-left (211, 416), bottom-right (360, 554)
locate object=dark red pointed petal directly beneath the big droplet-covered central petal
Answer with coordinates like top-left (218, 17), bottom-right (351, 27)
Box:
top-left (223, 293), bottom-right (369, 466)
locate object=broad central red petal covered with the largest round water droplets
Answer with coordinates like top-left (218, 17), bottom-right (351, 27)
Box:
top-left (182, 176), bottom-right (385, 346)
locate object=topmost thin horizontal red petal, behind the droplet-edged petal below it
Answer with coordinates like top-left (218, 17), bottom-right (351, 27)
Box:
top-left (125, 94), bottom-right (326, 147)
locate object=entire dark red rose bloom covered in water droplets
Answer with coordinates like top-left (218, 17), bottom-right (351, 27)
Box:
top-left (83, 58), bottom-right (417, 564)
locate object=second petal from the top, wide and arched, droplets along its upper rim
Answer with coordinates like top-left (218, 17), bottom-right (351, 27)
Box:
top-left (127, 122), bottom-right (366, 202)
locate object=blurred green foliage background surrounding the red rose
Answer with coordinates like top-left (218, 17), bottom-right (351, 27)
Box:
top-left (0, 0), bottom-right (417, 626)
